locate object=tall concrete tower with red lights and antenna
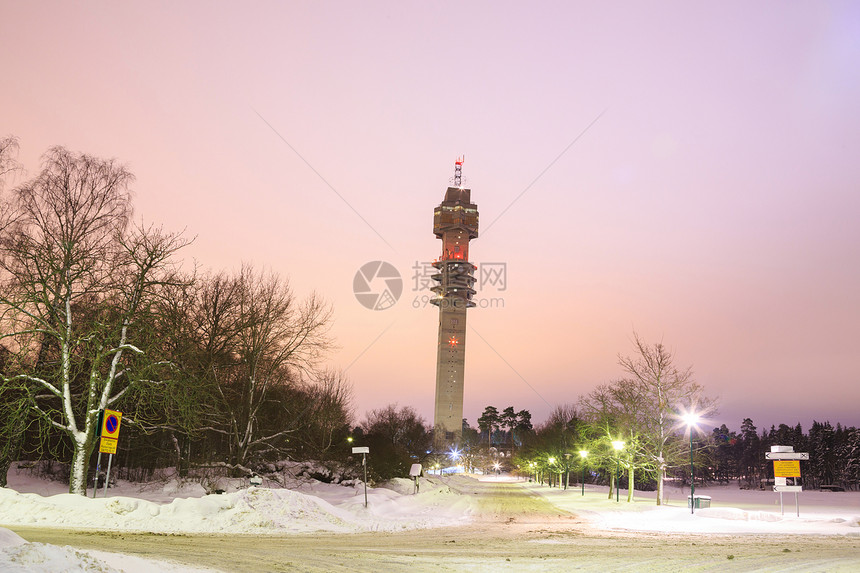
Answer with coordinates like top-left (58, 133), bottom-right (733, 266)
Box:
top-left (431, 159), bottom-right (478, 445)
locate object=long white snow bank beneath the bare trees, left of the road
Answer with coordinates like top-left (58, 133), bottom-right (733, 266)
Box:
top-left (0, 474), bottom-right (473, 534)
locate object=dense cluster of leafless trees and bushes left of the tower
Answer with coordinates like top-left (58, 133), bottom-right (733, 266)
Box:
top-left (0, 137), bottom-right (352, 494)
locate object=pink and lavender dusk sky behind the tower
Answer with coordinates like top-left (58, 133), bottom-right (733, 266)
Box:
top-left (0, 1), bottom-right (860, 429)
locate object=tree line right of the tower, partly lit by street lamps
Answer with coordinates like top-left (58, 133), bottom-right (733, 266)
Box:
top-left (478, 333), bottom-right (860, 496)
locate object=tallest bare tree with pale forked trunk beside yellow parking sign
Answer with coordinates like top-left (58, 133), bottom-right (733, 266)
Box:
top-left (0, 147), bottom-right (187, 495)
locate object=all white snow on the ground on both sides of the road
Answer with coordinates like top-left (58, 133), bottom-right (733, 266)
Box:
top-left (0, 462), bottom-right (860, 573)
